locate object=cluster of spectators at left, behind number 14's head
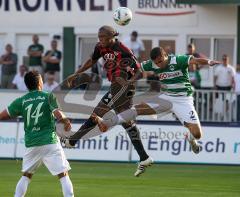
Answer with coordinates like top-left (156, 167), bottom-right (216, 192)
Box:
top-left (0, 35), bottom-right (62, 91)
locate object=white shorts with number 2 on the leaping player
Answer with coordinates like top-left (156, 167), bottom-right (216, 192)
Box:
top-left (158, 94), bottom-right (200, 125)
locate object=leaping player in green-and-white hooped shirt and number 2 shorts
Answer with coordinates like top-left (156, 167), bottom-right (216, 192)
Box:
top-left (95, 47), bottom-right (220, 171)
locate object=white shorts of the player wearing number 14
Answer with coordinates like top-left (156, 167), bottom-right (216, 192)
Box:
top-left (22, 143), bottom-right (71, 176)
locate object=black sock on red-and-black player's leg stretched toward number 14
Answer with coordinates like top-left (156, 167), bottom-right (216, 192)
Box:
top-left (69, 117), bottom-right (97, 146)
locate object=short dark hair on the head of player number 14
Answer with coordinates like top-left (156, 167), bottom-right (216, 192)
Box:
top-left (24, 71), bottom-right (41, 90)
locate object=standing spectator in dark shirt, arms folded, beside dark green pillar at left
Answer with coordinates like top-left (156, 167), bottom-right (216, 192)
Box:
top-left (43, 40), bottom-right (62, 82)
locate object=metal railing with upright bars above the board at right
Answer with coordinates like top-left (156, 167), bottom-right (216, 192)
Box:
top-left (194, 90), bottom-right (237, 122)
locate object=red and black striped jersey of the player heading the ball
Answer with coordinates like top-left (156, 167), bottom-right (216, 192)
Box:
top-left (92, 40), bottom-right (140, 81)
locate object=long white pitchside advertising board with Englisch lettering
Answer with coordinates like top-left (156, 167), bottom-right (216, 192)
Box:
top-left (0, 122), bottom-right (240, 164)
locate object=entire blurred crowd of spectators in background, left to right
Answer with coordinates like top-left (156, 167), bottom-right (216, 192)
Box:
top-left (0, 31), bottom-right (240, 120)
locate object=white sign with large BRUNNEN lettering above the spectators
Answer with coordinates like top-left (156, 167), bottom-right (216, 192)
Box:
top-left (0, 0), bottom-right (197, 28)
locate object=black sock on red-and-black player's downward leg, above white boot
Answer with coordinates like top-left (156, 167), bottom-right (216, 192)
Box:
top-left (122, 124), bottom-right (149, 161)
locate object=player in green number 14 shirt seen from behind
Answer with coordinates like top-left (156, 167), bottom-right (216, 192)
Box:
top-left (0, 71), bottom-right (74, 197)
